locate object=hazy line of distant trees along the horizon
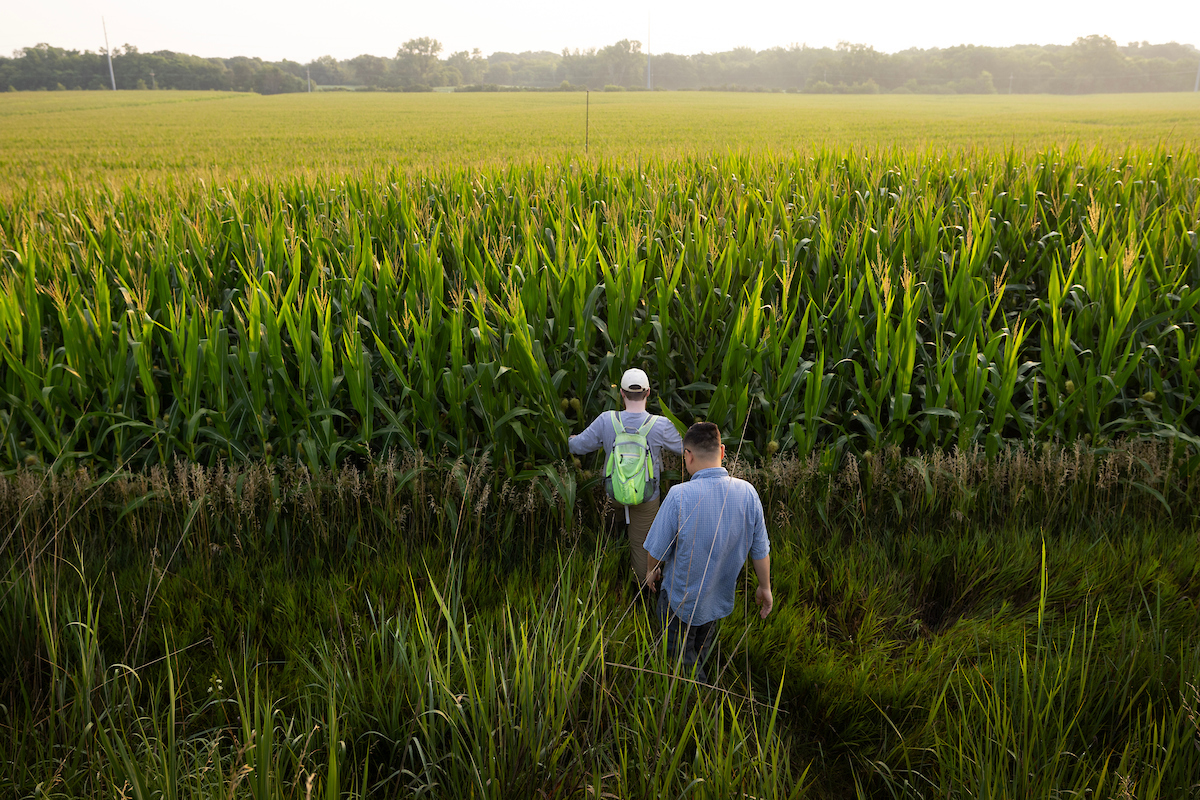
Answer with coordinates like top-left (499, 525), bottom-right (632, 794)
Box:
top-left (0, 35), bottom-right (1200, 94)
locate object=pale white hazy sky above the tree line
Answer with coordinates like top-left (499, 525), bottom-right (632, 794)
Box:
top-left (0, 0), bottom-right (1200, 62)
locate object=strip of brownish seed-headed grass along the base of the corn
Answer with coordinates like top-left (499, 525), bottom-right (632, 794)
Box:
top-left (0, 441), bottom-right (1200, 577)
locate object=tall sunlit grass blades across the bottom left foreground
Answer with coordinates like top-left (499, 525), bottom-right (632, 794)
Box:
top-left (0, 563), bottom-right (806, 800)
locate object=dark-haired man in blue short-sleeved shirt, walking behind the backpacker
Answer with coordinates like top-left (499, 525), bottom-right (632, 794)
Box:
top-left (646, 422), bottom-right (774, 682)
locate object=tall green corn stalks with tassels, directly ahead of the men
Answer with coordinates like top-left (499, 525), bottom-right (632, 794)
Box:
top-left (0, 148), bottom-right (1200, 477)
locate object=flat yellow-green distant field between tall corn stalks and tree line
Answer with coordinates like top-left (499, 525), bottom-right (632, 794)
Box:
top-left (0, 91), bottom-right (1200, 192)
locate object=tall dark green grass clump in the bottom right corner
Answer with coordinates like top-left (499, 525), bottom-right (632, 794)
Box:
top-left (871, 546), bottom-right (1200, 799)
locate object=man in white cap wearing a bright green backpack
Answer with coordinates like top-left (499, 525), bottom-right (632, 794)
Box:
top-left (568, 367), bottom-right (683, 585)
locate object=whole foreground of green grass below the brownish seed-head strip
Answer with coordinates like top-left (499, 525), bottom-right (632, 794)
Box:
top-left (0, 510), bottom-right (1200, 800)
